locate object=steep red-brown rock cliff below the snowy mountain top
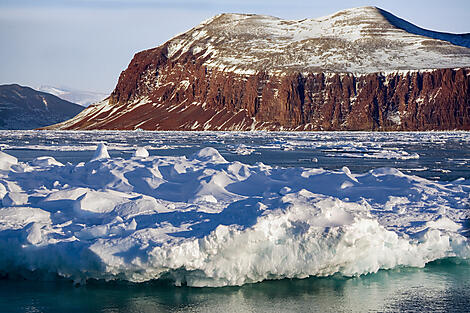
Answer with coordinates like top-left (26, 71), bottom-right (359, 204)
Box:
top-left (57, 46), bottom-right (470, 131)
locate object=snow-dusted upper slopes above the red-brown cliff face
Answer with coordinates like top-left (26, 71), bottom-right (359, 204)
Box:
top-left (166, 7), bottom-right (470, 75)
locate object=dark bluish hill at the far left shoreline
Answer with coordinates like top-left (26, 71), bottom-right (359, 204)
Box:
top-left (0, 84), bottom-right (84, 129)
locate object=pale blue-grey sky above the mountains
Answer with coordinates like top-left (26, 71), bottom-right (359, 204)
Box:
top-left (0, 0), bottom-right (470, 93)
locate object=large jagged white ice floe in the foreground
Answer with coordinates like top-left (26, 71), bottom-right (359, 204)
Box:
top-left (0, 144), bottom-right (470, 286)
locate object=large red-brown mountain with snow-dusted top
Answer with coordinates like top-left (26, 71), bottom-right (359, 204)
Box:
top-left (46, 7), bottom-right (470, 131)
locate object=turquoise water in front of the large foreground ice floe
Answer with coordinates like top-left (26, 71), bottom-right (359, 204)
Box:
top-left (0, 260), bottom-right (470, 313)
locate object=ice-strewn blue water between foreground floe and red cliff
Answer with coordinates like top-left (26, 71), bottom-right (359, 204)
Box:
top-left (0, 131), bottom-right (470, 181)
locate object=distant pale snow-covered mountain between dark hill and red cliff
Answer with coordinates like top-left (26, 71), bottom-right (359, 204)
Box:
top-left (37, 85), bottom-right (108, 107)
